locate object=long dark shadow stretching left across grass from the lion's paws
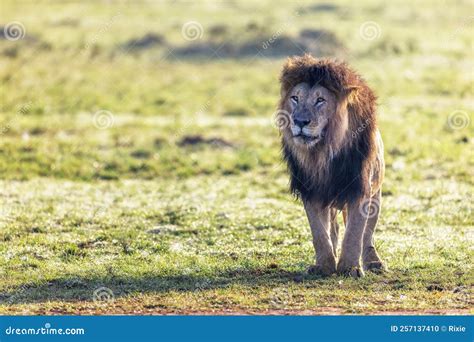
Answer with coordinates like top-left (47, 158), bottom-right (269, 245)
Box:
top-left (0, 267), bottom-right (316, 305)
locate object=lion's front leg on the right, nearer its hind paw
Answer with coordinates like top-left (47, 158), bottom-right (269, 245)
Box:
top-left (337, 201), bottom-right (367, 278)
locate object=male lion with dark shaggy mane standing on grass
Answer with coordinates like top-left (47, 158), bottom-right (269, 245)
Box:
top-left (278, 55), bottom-right (386, 278)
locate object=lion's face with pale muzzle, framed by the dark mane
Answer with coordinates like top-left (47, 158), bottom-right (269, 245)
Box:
top-left (285, 83), bottom-right (337, 147)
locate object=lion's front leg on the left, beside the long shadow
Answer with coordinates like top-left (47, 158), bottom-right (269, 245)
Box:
top-left (304, 201), bottom-right (336, 276)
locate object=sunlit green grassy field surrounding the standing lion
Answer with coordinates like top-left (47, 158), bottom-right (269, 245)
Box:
top-left (0, 0), bottom-right (474, 314)
